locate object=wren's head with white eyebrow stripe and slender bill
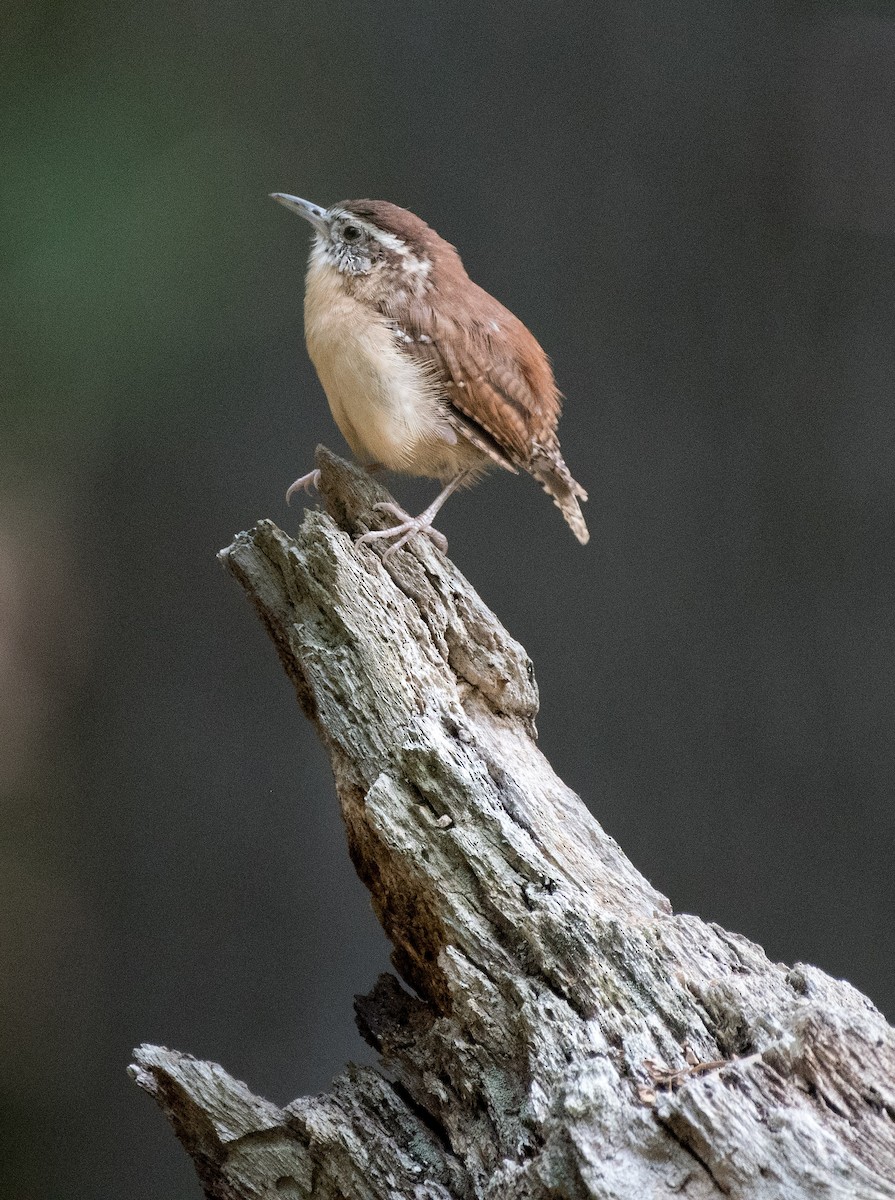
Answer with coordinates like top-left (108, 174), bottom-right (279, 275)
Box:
top-left (271, 192), bottom-right (459, 302)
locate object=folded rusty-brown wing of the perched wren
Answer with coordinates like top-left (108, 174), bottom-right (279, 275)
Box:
top-left (388, 280), bottom-right (560, 470)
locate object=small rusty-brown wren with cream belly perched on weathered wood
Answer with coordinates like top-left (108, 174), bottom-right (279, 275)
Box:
top-left (272, 192), bottom-right (589, 553)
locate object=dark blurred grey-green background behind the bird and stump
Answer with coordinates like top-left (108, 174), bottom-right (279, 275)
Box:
top-left (0, 0), bottom-right (895, 1200)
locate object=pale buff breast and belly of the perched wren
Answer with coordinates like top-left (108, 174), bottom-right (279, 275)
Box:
top-left (305, 276), bottom-right (481, 478)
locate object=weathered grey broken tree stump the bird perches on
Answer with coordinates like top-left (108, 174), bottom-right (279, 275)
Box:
top-left (132, 450), bottom-right (895, 1200)
